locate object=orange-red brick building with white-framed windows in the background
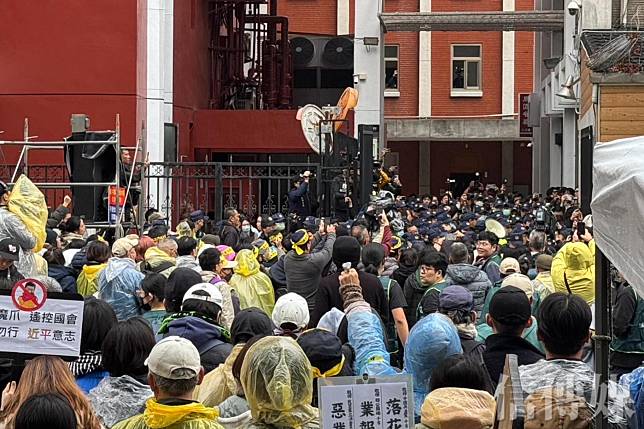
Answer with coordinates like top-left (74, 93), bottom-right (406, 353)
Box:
top-left (279, 0), bottom-right (534, 193)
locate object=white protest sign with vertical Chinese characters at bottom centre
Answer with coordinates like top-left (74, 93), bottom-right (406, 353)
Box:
top-left (318, 375), bottom-right (414, 429)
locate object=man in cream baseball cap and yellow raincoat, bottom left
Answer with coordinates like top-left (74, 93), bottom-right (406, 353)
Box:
top-left (112, 337), bottom-right (222, 429)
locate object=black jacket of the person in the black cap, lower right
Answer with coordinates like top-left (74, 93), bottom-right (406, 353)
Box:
top-left (483, 334), bottom-right (545, 385)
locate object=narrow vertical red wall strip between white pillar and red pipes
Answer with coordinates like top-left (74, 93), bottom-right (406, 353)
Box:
top-left (173, 0), bottom-right (210, 158)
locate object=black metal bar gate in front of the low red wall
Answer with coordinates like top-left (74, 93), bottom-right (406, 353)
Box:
top-left (143, 162), bottom-right (321, 223)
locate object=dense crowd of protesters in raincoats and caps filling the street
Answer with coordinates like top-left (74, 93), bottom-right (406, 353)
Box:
top-left (0, 175), bottom-right (644, 429)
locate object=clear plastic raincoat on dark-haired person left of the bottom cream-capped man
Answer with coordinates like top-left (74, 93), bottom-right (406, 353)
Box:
top-left (88, 375), bottom-right (154, 428)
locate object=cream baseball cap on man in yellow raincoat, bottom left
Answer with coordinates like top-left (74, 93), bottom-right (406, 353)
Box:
top-left (145, 336), bottom-right (201, 380)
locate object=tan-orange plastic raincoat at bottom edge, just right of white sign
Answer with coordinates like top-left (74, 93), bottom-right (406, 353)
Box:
top-left (416, 387), bottom-right (496, 429)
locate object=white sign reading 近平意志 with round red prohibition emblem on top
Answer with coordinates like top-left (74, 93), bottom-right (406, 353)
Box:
top-left (0, 279), bottom-right (84, 356)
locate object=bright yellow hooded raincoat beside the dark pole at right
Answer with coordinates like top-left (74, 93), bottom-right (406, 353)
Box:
top-left (550, 240), bottom-right (595, 304)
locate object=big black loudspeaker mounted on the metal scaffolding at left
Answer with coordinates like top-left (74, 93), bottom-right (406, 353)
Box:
top-left (65, 131), bottom-right (116, 223)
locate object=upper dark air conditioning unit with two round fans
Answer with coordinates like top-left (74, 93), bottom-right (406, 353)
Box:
top-left (291, 36), bottom-right (353, 70)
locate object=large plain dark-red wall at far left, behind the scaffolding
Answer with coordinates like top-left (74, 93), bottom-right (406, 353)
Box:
top-left (0, 0), bottom-right (145, 166)
